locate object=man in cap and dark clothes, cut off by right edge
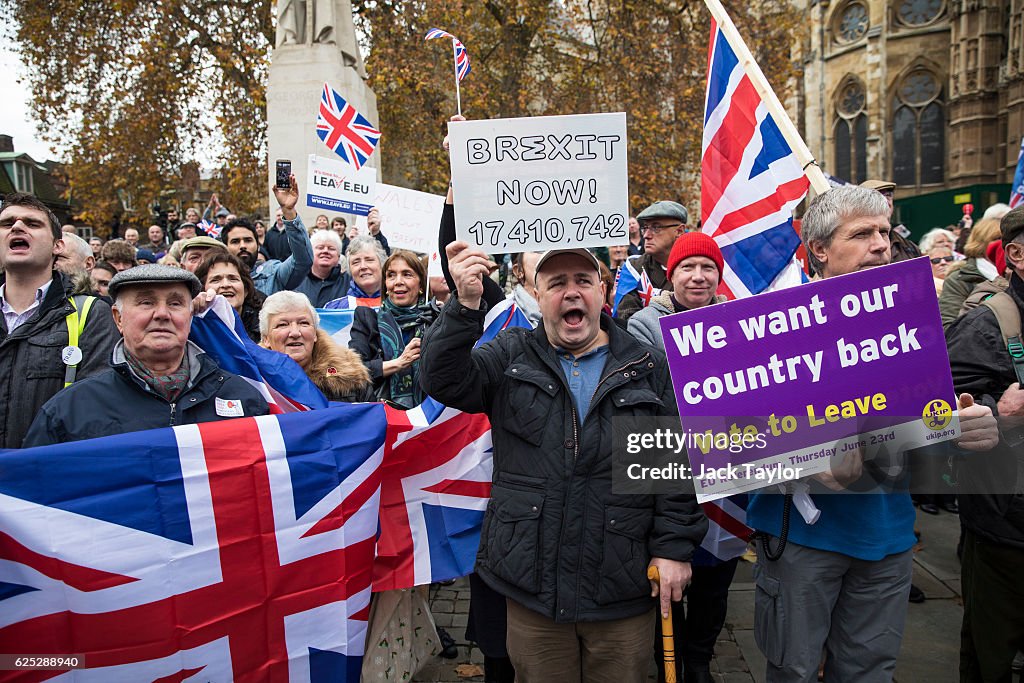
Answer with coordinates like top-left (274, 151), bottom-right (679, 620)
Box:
top-left (946, 207), bottom-right (1024, 683)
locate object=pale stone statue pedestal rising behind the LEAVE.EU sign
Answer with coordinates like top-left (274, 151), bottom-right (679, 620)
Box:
top-left (266, 0), bottom-right (380, 227)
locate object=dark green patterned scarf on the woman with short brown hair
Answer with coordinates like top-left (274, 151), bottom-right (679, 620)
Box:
top-left (377, 298), bottom-right (436, 410)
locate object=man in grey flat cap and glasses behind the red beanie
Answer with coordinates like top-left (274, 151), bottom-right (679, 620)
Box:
top-left (615, 201), bottom-right (689, 323)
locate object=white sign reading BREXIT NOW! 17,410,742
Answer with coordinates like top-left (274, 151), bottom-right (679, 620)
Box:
top-left (449, 114), bottom-right (629, 254)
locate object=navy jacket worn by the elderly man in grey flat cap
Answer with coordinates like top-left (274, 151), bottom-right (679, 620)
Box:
top-left (24, 341), bottom-right (269, 447)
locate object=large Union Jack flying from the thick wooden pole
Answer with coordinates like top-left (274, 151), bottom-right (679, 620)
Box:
top-left (700, 20), bottom-right (810, 299)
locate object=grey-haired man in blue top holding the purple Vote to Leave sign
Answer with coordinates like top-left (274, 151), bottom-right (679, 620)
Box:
top-left (746, 185), bottom-right (999, 683)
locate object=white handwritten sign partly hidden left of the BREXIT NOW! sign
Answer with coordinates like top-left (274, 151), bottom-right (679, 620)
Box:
top-left (370, 182), bottom-right (444, 254)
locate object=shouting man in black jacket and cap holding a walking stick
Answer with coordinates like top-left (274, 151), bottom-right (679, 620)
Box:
top-left (420, 242), bottom-right (707, 683)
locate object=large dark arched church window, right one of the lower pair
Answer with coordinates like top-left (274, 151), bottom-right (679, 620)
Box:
top-left (892, 68), bottom-right (946, 187)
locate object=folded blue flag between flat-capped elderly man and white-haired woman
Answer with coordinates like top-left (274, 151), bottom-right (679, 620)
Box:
top-left (188, 296), bottom-right (328, 413)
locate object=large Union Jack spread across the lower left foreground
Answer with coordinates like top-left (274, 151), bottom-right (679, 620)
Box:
top-left (0, 404), bottom-right (387, 683)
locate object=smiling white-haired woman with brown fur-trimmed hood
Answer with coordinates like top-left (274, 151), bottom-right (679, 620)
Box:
top-left (259, 291), bottom-right (377, 402)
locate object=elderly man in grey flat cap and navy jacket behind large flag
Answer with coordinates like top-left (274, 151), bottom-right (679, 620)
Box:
top-left (25, 264), bottom-right (268, 447)
